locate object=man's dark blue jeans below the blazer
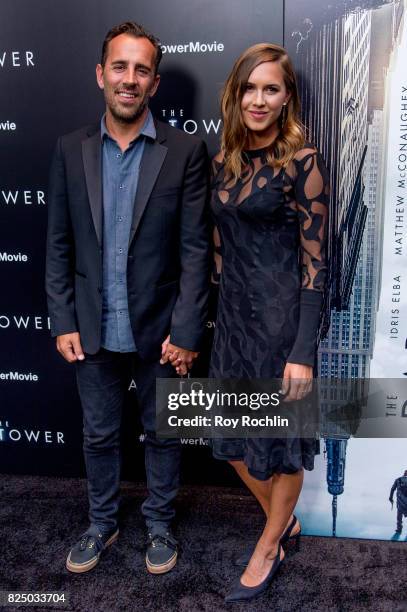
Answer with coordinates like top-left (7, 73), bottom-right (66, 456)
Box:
top-left (76, 349), bottom-right (181, 533)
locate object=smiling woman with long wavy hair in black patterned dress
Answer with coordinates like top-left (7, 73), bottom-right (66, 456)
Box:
top-left (210, 43), bottom-right (329, 601)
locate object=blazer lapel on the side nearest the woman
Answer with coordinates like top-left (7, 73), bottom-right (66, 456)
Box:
top-left (129, 139), bottom-right (168, 244)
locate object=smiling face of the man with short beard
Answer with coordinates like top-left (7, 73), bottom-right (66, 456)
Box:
top-left (96, 34), bottom-right (160, 123)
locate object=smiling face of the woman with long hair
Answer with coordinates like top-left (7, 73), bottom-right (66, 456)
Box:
top-left (240, 62), bottom-right (290, 137)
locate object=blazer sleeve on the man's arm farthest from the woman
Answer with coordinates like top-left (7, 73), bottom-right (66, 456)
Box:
top-left (45, 139), bottom-right (78, 336)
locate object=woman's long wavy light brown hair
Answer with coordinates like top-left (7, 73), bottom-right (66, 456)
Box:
top-left (221, 43), bottom-right (305, 180)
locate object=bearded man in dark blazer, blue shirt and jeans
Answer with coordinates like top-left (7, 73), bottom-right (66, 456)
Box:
top-left (46, 22), bottom-right (208, 574)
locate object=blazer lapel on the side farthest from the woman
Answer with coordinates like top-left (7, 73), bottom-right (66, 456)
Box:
top-left (82, 130), bottom-right (102, 245)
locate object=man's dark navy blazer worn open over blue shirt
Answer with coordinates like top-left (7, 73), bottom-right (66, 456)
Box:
top-left (46, 121), bottom-right (209, 359)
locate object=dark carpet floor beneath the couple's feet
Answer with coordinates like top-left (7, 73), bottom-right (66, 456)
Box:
top-left (0, 476), bottom-right (407, 612)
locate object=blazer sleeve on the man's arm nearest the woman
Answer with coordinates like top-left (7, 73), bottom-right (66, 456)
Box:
top-left (170, 142), bottom-right (210, 351)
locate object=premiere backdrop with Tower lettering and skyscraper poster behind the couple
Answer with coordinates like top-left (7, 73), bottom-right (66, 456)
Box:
top-left (0, 0), bottom-right (407, 539)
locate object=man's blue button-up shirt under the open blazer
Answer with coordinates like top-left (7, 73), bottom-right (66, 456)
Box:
top-left (101, 112), bottom-right (156, 353)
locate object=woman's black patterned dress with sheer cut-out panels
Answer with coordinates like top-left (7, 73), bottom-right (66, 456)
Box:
top-left (210, 144), bottom-right (329, 480)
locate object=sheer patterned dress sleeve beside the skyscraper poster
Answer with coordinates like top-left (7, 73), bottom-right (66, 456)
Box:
top-left (288, 146), bottom-right (329, 366)
